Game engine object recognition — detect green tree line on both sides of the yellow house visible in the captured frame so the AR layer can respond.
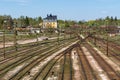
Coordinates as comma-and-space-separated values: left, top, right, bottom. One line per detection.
0, 15, 120, 29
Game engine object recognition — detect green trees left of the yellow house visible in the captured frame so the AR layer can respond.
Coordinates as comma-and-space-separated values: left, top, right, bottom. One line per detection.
0, 15, 43, 29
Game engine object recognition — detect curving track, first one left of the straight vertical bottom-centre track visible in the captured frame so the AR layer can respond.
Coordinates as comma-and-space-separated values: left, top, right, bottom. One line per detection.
32, 49, 64, 80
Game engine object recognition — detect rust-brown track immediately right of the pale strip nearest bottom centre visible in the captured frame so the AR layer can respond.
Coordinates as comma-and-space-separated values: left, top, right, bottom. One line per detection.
76, 45, 99, 80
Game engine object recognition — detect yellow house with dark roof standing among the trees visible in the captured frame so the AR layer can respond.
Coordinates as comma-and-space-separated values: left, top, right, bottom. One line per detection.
43, 14, 57, 28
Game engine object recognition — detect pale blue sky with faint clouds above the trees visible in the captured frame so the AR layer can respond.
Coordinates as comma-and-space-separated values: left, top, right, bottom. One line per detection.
0, 0, 120, 21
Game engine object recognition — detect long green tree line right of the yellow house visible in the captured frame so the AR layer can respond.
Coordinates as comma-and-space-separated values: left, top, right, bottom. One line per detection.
58, 16, 120, 27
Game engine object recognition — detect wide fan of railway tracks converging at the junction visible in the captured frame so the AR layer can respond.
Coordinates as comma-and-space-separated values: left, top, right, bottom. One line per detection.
0, 32, 120, 80
